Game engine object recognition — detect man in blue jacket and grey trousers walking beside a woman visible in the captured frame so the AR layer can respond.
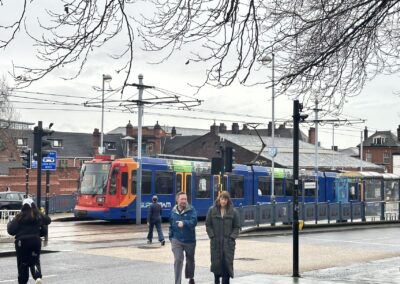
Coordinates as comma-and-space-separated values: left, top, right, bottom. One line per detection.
169, 191, 197, 284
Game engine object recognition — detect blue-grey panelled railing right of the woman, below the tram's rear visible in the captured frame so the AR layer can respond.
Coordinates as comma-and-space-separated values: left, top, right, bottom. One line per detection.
238, 201, 400, 227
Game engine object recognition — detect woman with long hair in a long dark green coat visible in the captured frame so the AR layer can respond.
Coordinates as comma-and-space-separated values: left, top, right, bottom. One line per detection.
206, 191, 240, 284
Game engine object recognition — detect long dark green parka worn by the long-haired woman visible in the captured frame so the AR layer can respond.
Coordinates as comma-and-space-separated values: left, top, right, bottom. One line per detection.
206, 205, 240, 278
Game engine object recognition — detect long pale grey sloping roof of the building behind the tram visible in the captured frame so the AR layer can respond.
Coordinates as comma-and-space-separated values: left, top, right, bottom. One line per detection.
219, 134, 382, 170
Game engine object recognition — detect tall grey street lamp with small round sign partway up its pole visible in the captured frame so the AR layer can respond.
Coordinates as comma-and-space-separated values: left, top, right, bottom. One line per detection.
261, 51, 277, 201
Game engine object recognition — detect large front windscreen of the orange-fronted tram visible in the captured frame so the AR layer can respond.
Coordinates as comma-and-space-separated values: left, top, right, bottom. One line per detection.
80, 163, 111, 194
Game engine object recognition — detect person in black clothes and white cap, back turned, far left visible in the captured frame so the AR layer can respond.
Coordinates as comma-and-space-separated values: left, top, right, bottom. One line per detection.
7, 198, 51, 284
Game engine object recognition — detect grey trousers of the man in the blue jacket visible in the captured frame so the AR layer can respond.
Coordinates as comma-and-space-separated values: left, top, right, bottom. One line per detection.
171, 239, 196, 284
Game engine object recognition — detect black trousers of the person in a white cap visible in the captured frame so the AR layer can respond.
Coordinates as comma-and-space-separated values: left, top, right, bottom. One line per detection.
15, 237, 42, 284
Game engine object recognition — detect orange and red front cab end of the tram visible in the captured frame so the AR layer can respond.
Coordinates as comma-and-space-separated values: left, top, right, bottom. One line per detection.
74, 155, 138, 220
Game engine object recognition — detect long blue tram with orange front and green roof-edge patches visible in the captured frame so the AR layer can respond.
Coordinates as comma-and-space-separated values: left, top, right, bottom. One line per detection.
74, 155, 399, 220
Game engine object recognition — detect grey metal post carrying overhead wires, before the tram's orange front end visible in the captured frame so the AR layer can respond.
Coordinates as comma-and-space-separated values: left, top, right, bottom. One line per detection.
136, 74, 144, 225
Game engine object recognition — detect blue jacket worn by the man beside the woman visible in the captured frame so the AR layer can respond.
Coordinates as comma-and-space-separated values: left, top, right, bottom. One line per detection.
169, 204, 197, 243
